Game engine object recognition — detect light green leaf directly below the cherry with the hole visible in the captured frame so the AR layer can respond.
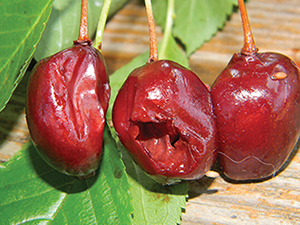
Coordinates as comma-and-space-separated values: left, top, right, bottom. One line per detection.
120, 141, 188, 225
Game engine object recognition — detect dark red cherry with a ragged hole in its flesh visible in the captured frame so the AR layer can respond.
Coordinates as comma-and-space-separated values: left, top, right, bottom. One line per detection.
113, 60, 217, 183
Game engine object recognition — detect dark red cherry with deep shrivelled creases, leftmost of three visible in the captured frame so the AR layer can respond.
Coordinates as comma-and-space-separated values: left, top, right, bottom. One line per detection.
26, 45, 110, 177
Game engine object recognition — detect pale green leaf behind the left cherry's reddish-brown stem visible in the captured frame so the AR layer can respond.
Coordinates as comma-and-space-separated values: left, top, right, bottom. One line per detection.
34, 0, 129, 61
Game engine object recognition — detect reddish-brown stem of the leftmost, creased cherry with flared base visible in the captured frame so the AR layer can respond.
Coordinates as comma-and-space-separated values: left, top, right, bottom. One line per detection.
74, 0, 92, 45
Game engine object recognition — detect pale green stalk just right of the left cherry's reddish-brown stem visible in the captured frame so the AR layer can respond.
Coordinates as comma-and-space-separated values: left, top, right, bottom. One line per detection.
94, 0, 111, 51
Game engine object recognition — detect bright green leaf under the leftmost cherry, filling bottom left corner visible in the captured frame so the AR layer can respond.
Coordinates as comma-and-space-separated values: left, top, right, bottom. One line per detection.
0, 129, 133, 225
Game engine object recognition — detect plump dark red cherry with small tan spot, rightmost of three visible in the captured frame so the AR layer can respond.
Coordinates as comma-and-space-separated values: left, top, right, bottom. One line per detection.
211, 53, 300, 180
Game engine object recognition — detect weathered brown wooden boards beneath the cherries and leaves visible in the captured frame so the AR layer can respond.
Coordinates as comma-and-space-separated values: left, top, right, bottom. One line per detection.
0, 0, 300, 225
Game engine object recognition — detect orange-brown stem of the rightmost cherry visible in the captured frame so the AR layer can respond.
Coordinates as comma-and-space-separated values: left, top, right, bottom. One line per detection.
238, 0, 258, 55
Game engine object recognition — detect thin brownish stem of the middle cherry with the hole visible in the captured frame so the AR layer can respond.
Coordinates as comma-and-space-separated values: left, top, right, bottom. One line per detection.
145, 0, 158, 62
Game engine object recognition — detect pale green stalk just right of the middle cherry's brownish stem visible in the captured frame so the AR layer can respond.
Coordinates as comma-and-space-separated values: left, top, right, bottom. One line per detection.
159, 0, 175, 59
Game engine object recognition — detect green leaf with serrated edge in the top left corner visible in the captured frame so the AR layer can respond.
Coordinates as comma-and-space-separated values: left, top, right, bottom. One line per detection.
0, 0, 53, 111
